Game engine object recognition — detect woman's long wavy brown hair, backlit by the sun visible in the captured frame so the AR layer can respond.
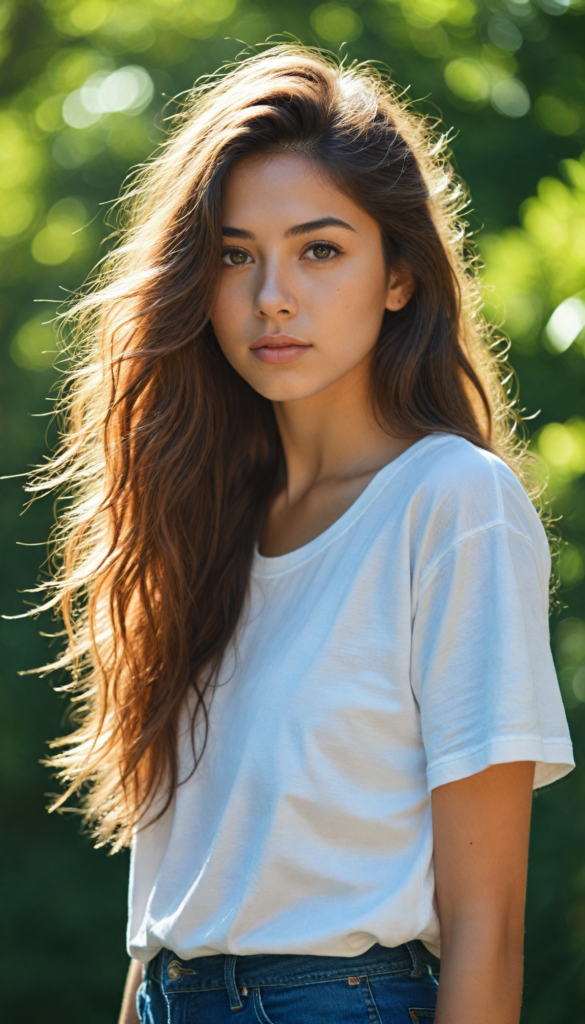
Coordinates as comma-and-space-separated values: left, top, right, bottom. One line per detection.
26, 44, 521, 846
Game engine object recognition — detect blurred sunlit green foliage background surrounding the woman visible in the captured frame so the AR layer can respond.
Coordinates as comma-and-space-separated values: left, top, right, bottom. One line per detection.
0, 0, 585, 1024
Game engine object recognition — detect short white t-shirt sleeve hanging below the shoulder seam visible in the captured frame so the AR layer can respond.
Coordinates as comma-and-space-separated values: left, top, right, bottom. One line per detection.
411, 520, 575, 791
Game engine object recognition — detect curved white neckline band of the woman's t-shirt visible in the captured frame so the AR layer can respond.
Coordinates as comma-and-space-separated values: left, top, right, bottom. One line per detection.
252, 433, 453, 577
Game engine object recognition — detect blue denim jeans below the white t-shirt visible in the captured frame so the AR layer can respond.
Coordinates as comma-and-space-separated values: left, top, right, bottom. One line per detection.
137, 941, 437, 1024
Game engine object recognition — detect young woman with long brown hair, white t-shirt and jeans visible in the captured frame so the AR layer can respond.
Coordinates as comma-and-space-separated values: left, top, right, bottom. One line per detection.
34, 46, 573, 1024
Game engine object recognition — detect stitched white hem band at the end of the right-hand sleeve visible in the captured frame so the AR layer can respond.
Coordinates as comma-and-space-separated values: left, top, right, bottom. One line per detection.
426, 736, 575, 792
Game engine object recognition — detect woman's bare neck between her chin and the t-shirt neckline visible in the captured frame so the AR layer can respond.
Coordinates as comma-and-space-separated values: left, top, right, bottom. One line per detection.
275, 357, 413, 503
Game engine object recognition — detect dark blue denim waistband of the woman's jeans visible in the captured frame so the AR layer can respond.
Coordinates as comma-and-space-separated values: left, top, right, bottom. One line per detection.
147, 940, 436, 994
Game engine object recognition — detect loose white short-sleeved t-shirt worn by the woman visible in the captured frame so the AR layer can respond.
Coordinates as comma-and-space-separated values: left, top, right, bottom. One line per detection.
128, 434, 574, 963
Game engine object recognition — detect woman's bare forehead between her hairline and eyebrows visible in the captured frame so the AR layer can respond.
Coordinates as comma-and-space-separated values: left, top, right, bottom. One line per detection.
223, 153, 377, 230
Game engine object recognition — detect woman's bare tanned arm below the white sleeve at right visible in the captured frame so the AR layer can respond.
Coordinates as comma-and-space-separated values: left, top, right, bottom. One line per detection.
432, 761, 534, 1024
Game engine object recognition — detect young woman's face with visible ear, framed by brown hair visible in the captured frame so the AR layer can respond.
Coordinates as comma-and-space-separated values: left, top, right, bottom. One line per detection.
211, 154, 414, 401
